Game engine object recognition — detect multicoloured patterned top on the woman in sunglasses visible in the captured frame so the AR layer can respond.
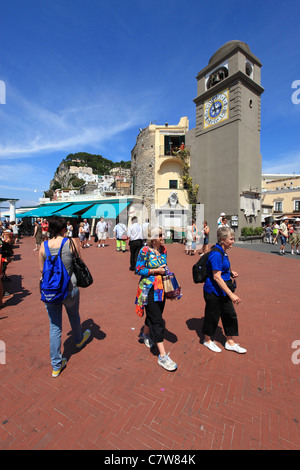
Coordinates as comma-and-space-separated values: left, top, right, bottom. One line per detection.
135, 245, 167, 317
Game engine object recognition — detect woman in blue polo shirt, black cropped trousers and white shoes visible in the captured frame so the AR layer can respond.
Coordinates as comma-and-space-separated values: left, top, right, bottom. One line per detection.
202, 227, 247, 354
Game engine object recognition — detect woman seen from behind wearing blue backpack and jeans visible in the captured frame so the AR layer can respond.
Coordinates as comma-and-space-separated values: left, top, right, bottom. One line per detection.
39, 216, 91, 377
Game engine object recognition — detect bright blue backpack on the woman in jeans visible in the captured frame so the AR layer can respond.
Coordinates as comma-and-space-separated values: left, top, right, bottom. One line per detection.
40, 238, 70, 303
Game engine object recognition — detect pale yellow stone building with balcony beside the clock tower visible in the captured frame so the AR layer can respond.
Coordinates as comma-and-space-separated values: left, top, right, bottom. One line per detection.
131, 117, 189, 230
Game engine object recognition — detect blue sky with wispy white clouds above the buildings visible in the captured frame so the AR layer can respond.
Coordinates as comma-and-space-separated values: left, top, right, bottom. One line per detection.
0, 0, 300, 206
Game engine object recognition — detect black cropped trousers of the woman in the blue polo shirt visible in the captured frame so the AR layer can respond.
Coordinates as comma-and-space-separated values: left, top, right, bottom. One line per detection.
202, 291, 239, 336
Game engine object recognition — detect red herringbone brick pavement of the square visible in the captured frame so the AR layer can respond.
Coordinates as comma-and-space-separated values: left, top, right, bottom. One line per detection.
0, 238, 300, 451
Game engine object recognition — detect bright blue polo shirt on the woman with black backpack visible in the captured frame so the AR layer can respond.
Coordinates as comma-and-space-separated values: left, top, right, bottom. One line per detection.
203, 243, 230, 296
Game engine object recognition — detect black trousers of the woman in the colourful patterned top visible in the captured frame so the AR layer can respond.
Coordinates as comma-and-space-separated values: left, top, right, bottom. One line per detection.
145, 287, 165, 343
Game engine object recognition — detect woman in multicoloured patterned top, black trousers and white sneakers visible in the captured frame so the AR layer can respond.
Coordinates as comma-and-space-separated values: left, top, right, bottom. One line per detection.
135, 230, 177, 371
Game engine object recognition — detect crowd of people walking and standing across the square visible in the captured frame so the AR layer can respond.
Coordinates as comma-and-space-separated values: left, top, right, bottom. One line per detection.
0, 213, 300, 377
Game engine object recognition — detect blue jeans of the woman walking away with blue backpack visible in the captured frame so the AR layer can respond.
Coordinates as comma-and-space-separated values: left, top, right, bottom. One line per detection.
45, 287, 83, 370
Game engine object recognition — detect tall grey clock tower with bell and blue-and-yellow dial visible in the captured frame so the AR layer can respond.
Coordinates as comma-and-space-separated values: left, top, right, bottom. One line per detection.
186, 41, 264, 242
